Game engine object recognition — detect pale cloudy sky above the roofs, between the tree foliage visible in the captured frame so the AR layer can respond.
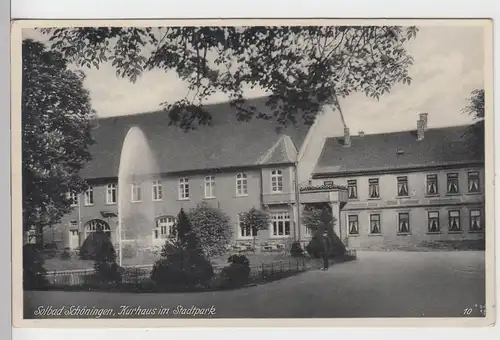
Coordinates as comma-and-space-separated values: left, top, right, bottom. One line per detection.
23, 25, 484, 135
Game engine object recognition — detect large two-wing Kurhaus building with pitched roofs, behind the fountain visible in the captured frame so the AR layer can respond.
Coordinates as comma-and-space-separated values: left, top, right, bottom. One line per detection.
39, 100, 484, 249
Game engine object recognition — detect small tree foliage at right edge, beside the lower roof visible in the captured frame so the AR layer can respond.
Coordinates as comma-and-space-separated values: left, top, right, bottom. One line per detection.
462, 89, 484, 157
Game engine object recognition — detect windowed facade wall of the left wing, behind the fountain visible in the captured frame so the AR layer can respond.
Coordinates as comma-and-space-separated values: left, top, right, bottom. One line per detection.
45, 165, 295, 248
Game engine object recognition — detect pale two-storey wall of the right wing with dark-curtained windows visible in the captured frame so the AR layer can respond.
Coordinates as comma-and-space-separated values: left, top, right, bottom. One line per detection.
314, 167, 484, 249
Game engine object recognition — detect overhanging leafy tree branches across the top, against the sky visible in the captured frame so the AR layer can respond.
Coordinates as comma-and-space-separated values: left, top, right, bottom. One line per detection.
40, 26, 418, 129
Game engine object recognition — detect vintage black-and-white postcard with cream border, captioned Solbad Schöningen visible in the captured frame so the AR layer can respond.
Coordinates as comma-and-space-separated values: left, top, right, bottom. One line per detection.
12, 19, 496, 327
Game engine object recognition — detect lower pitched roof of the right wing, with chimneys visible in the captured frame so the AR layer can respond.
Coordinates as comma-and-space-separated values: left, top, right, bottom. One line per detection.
313, 126, 484, 176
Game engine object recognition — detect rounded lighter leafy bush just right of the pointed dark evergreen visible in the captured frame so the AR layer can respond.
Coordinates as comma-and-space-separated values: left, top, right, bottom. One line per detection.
187, 203, 232, 257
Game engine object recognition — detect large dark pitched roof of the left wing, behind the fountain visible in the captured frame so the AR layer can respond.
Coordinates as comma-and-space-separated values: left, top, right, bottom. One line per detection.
82, 98, 309, 179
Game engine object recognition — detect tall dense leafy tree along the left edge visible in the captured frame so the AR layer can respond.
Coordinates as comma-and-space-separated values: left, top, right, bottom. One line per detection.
22, 40, 94, 247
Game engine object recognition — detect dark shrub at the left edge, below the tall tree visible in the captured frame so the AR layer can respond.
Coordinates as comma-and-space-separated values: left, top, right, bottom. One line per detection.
23, 244, 48, 290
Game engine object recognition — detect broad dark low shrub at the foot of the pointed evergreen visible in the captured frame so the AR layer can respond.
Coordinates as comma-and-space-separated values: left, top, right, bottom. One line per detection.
151, 244, 214, 287
